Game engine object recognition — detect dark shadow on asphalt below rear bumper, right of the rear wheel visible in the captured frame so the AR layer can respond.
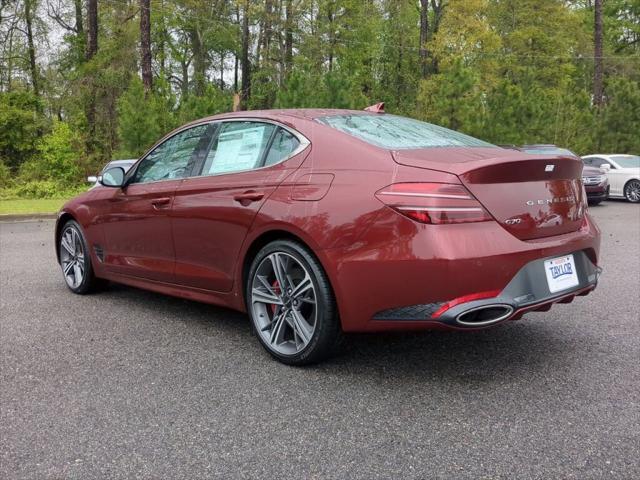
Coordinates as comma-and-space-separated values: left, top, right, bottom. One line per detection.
316, 317, 585, 388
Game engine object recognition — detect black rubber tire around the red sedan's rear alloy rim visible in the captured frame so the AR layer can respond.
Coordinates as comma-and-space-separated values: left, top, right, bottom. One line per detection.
245, 240, 342, 365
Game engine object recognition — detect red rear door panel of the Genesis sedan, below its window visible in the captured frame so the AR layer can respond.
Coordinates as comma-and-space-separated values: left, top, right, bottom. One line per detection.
171, 147, 308, 292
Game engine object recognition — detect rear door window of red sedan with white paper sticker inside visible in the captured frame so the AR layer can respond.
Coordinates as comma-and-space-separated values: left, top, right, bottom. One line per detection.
202, 121, 277, 175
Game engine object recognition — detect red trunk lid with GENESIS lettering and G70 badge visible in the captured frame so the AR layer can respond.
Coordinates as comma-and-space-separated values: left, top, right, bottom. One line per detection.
392, 148, 586, 240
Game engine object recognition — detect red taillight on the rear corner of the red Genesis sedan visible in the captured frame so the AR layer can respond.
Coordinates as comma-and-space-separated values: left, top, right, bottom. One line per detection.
376, 183, 493, 225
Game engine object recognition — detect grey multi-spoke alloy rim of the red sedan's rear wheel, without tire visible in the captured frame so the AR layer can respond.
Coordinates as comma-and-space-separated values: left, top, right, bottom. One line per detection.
251, 252, 318, 355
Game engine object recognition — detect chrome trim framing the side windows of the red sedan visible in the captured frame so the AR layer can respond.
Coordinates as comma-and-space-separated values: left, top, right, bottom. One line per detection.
125, 117, 311, 187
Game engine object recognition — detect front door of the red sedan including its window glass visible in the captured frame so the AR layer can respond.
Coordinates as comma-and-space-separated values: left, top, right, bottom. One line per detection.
100, 124, 211, 282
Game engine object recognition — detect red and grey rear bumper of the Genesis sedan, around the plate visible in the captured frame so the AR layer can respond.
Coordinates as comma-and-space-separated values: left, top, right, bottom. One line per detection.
323, 212, 600, 332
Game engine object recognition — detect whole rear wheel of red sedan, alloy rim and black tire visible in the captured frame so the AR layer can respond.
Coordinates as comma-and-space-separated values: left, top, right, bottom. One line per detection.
245, 240, 341, 365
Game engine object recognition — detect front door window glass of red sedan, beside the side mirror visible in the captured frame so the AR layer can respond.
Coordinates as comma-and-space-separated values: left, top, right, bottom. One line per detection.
132, 125, 210, 183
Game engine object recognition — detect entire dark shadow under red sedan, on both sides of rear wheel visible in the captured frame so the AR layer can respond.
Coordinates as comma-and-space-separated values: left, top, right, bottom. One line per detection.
105, 284, 585, 383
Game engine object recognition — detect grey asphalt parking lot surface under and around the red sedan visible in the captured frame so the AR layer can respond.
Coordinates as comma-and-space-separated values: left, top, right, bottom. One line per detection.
0, 201, 640, 479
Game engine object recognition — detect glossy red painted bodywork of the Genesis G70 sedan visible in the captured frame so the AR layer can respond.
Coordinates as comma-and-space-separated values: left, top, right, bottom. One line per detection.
55, 110, 600, 331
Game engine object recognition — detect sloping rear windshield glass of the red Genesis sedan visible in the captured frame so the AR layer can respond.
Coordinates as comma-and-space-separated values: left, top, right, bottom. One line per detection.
317, 114, 495, 150
